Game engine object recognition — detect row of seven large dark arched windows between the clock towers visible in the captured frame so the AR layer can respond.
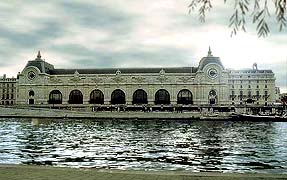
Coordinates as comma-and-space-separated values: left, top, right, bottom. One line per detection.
48, 89, 193, 104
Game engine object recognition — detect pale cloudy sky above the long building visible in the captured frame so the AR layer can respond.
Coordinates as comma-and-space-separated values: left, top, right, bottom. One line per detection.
0, 0, 287, 92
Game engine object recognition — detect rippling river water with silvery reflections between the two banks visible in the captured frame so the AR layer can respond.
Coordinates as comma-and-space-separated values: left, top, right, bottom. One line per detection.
0, 119, 287, 174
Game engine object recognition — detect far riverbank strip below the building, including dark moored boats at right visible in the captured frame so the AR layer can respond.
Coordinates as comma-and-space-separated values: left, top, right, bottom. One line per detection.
0, 106, 287, 122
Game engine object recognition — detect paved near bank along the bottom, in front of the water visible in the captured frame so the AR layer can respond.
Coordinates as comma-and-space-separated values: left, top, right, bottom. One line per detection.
0, 165, 287, 180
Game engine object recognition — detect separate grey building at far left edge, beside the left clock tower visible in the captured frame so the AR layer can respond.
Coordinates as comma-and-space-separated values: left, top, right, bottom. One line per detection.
0, 74, 16, 105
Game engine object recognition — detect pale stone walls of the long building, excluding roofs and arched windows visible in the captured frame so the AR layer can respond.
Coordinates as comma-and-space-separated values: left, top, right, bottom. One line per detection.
17, 53, 275, 105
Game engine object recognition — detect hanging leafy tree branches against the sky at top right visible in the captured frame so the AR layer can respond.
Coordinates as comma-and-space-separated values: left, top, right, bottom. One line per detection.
188, 0, 287, 37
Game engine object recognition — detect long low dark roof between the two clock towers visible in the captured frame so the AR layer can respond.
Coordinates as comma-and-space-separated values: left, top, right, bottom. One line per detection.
48, 67, 197, 75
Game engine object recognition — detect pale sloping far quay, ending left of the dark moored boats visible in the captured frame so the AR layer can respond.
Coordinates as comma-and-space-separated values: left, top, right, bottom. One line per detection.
0, 107, 231, 120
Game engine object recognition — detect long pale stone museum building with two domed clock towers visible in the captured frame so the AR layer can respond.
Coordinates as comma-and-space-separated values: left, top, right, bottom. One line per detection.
16, 49, 275, 107
